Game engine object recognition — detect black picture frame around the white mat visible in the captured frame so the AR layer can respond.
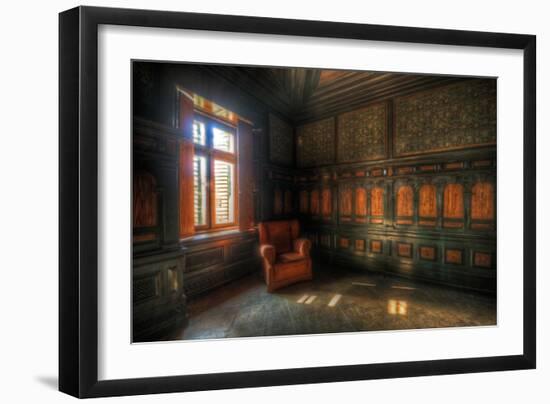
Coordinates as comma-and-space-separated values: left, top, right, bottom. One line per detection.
59, 7, 536, 398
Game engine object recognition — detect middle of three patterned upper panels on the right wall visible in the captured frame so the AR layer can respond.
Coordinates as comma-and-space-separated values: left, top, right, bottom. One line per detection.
338, 102, 387, 163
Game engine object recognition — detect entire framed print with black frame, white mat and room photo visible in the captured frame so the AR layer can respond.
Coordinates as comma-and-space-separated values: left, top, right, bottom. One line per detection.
59, 7, 536, 397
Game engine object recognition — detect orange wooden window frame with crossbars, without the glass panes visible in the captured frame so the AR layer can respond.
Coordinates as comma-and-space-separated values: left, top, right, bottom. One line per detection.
193, 113, 239, 233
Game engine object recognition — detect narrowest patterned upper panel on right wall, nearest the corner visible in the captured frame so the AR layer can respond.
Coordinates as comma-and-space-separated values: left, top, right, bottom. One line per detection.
296, 118, 335, 167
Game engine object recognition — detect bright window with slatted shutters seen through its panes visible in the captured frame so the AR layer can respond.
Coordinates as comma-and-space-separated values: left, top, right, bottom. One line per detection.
193, 117, 237, 230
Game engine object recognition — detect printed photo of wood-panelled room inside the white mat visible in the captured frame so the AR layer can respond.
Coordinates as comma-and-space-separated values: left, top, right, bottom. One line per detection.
132, 61, 497, 342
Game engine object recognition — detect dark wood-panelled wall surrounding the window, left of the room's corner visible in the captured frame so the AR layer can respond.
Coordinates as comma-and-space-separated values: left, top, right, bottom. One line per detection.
132, 62, 293, 341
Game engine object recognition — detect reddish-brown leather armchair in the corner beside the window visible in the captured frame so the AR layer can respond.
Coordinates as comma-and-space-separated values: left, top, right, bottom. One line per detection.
259, 220, 313, 292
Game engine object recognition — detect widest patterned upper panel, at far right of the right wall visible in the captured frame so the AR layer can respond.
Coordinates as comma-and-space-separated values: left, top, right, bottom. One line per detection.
394, 79, 496, 156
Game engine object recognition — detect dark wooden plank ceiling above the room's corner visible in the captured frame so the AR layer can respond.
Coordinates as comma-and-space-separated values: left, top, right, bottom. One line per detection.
208, 66, 457, 124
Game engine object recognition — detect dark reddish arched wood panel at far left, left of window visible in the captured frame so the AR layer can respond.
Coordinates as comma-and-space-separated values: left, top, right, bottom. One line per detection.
133, 171, 157, 227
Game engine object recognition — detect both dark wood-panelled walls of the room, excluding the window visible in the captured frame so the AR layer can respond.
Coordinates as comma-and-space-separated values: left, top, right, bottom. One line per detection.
132, 67, 496, 341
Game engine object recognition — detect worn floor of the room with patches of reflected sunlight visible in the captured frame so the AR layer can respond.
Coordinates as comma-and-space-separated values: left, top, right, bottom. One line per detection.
174, 271, 496, 339
